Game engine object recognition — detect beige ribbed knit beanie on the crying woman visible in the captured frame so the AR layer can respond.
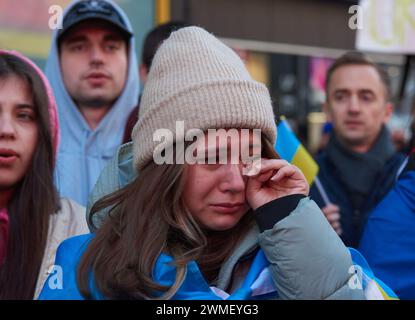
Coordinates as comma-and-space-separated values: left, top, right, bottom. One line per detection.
132, 27, 276, 170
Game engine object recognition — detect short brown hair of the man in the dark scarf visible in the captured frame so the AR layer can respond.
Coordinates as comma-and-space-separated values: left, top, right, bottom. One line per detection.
326, 51, 391, 101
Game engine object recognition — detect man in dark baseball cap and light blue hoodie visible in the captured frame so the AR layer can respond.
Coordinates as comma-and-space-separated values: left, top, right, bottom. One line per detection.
45, 0, 139, 205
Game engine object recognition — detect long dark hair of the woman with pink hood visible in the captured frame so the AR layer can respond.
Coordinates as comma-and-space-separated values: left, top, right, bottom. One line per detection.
0, 54, 59, 300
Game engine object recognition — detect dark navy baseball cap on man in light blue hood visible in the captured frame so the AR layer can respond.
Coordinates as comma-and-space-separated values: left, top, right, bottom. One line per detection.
58, 0, 133, 37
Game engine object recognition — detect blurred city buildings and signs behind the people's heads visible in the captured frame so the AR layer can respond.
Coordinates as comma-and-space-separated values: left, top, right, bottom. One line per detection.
0, 0, 415, 153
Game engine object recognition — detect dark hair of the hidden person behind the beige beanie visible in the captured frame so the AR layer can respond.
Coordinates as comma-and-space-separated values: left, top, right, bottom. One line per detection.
141, 21, 189, 70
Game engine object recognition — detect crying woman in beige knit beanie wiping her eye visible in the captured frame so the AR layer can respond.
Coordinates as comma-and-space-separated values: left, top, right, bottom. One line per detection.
40, 27, 394, 300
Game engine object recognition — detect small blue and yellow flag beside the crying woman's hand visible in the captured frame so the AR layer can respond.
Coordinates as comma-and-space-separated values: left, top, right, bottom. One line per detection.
275, 117, 318, 185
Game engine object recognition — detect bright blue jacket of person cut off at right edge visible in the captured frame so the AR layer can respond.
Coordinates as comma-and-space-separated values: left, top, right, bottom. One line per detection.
360, 155, 415, 299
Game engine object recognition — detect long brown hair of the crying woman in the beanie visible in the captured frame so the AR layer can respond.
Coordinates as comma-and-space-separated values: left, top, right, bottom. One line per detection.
77, 138, 278, 299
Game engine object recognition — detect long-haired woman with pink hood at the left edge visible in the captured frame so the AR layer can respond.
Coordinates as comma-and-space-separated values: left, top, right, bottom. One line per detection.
0, 50, 88, 300
